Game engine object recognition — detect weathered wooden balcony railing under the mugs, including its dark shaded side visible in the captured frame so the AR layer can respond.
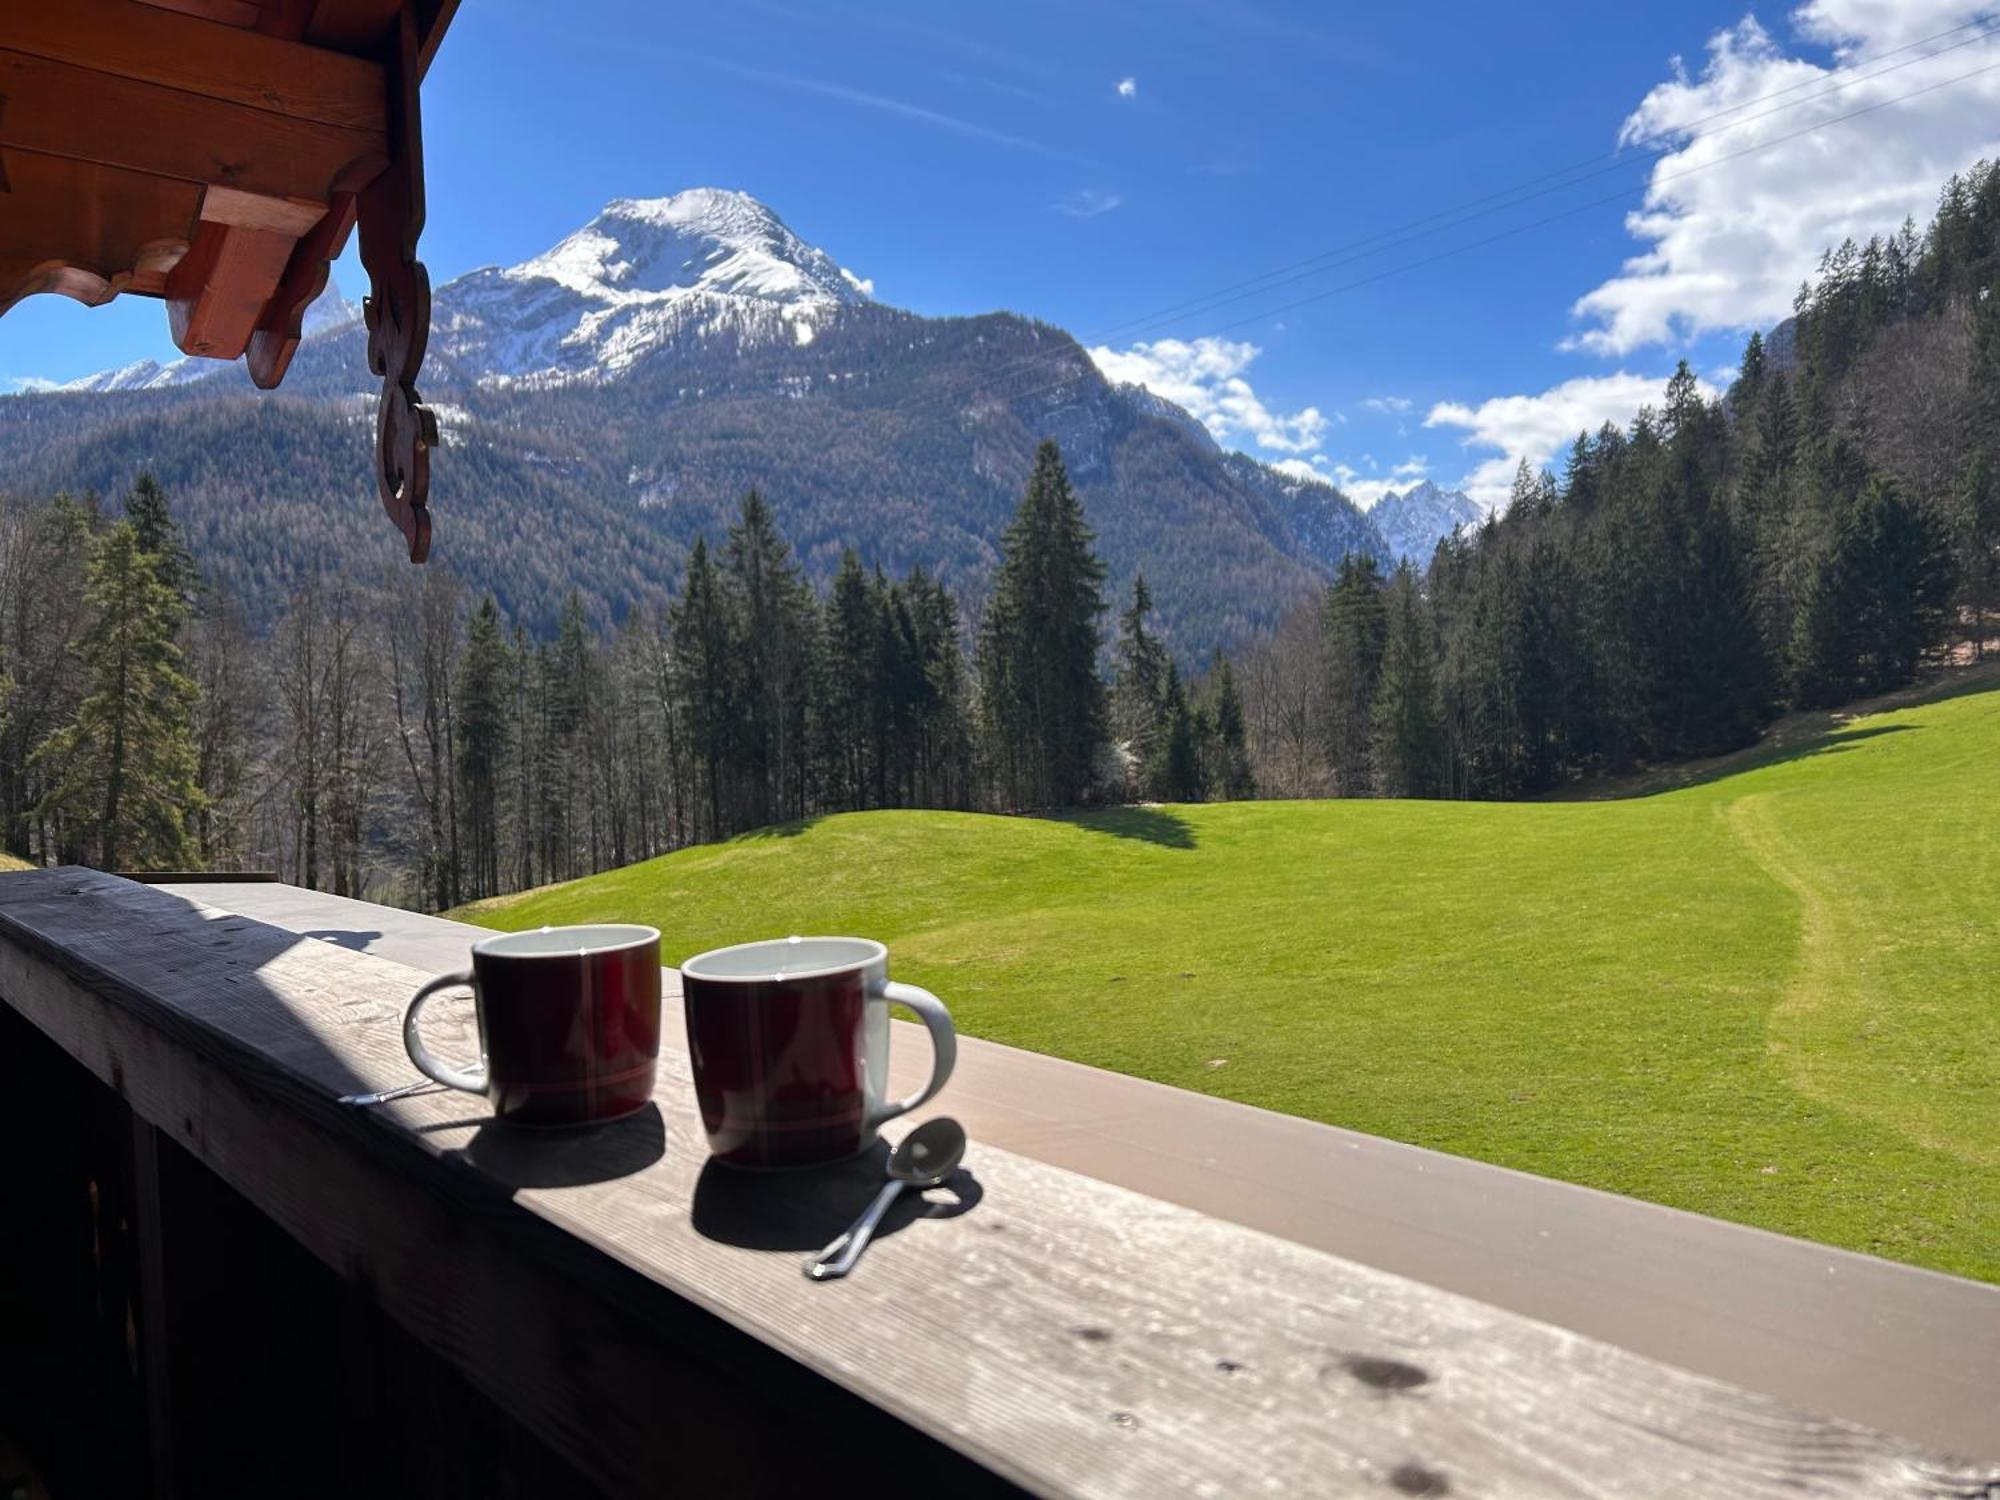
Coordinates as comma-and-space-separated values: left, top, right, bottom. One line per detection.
0, 870, 2000, 1500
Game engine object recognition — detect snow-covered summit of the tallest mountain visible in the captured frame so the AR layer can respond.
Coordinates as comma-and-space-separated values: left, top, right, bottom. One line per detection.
432, 188, 870, 384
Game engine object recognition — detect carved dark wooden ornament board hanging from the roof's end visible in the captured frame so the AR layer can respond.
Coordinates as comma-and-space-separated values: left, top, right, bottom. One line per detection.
356, 10, 438, 562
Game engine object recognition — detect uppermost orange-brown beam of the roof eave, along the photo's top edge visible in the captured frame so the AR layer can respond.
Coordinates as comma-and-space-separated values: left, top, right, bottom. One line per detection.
0, 0, 388, 132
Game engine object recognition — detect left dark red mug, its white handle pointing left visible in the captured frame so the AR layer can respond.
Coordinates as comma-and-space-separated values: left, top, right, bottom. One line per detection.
402, 924, 660, 1126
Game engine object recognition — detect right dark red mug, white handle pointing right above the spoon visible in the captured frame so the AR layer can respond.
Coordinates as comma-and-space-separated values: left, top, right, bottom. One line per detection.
680, 938, 958, 1168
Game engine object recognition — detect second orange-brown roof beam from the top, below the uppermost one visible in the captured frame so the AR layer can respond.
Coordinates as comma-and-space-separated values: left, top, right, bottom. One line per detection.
0, 48, 388, 210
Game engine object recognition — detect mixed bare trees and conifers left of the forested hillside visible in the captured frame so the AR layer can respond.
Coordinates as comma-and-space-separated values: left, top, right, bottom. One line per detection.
0, 434, 1248, 908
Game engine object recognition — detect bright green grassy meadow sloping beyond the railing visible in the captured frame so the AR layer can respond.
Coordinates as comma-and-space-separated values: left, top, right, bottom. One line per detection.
468, 688, 2000, 1280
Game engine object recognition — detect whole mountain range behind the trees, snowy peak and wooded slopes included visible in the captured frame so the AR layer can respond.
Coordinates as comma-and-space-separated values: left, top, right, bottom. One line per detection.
0, 188, 1464, 662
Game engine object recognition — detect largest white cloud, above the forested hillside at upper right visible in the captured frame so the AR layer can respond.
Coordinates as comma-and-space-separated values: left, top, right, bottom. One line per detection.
1570, 0, 2000, 354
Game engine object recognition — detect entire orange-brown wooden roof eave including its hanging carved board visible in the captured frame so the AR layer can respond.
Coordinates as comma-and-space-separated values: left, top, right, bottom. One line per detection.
0, 0, 456, 560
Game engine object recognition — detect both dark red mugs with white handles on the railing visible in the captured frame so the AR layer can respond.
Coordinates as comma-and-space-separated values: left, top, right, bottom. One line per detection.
402, 924, 958, 1168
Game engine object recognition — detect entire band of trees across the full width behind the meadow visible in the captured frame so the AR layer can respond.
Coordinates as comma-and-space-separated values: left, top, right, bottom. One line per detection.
0, 166, 2000, 908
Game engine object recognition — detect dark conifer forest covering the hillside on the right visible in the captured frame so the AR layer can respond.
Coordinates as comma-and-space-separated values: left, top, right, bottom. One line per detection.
1246, 164, 2000, 798
